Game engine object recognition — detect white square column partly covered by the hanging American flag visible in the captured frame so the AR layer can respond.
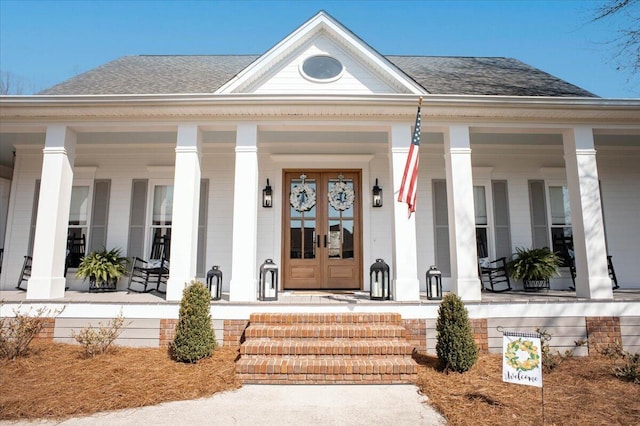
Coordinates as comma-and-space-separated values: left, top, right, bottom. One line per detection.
390, 124, 420, 301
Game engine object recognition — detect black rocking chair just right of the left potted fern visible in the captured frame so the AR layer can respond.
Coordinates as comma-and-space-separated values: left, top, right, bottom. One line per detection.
127, 235, 170, 293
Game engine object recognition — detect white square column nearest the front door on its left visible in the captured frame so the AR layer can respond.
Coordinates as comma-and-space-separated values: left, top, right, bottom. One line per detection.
229, 123, 258, 302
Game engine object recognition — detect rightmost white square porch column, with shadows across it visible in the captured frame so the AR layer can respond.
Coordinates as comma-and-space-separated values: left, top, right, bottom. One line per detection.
562, 126, 613, 299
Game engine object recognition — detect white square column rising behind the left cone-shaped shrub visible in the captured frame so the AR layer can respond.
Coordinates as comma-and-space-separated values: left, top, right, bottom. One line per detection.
166, 124, 202, 300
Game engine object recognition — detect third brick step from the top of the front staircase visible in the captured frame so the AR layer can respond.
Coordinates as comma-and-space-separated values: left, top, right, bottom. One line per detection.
240, 339, 413, 358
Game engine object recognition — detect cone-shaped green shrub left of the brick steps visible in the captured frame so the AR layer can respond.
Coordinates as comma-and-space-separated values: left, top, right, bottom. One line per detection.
171, 281, 216, 363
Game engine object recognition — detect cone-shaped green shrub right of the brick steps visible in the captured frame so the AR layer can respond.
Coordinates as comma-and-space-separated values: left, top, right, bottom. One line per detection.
436, 293, 478, 373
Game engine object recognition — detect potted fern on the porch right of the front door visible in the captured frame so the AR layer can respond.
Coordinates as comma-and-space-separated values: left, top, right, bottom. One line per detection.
507, 247, 562, 291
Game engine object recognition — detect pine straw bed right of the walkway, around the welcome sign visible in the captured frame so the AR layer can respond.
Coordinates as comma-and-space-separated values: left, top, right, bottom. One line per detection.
416, 355, 640, 425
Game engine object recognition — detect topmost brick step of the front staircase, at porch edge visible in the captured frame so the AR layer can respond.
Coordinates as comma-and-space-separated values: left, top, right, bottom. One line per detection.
249, 313, 402, 324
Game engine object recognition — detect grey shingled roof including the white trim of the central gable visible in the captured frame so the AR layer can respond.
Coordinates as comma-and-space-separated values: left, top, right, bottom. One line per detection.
39, 12, 595, 97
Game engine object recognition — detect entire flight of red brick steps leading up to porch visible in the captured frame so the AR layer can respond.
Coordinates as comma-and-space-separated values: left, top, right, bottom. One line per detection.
236, 313, 417, 384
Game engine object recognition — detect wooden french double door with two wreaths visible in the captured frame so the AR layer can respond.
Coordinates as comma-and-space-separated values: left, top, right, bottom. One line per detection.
282, 169, 362, 290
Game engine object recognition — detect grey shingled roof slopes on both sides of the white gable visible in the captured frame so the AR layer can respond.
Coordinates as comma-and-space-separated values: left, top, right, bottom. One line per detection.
39, 55, 595, 97
